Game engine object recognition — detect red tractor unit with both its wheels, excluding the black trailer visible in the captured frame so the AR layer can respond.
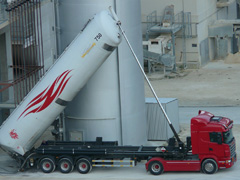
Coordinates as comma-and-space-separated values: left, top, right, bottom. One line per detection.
145, 111, 237, 175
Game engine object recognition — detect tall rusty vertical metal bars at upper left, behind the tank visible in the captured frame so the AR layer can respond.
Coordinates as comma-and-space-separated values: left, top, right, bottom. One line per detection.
0, 0, 44, 105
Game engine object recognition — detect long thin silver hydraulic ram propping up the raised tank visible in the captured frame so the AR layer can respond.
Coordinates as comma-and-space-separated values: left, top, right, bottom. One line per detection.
109, 6, 181, 142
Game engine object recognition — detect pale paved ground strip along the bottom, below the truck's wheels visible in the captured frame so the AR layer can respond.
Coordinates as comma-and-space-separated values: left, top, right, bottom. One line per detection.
0, 164, 240, 180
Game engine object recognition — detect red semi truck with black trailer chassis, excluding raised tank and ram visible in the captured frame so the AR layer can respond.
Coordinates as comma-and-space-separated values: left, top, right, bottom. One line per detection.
27, 111, 237, 175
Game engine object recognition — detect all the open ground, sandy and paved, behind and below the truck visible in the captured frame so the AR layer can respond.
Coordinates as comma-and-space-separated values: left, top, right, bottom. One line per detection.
0, 61, 240, 180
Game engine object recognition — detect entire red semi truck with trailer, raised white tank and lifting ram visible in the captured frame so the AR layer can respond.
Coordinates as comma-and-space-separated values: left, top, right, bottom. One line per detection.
0, 8, 237, 175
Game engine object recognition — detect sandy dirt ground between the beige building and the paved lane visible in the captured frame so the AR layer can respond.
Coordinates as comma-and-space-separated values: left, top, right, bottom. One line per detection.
145, 59, 240, 106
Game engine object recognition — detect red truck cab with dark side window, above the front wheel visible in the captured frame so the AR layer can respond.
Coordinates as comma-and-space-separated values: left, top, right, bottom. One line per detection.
191, 111, 237, 172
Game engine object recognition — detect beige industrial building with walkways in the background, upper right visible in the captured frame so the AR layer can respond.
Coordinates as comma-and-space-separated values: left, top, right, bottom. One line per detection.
141, 0, 239, 68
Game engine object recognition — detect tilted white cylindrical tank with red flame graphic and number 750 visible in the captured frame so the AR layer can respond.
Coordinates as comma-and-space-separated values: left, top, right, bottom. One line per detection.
0, 11, 121, 155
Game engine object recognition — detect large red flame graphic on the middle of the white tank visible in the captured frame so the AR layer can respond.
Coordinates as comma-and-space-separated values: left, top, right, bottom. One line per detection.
18, 70, 72, 119
